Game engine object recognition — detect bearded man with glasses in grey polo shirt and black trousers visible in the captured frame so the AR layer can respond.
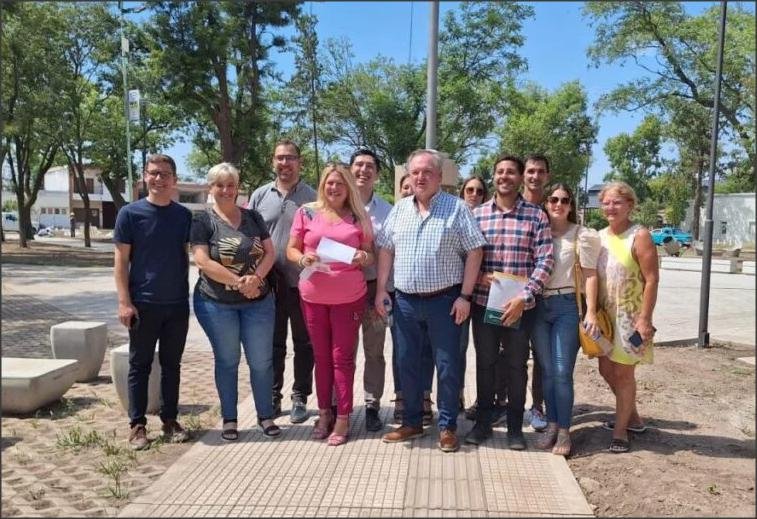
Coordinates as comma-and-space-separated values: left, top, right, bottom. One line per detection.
248, 139, 316, 423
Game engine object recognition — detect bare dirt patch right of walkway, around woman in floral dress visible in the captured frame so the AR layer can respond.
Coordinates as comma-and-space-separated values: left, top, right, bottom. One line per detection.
568, 346, 755, 517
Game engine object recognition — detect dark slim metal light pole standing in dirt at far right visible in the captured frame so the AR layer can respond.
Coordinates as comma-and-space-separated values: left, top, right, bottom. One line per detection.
698, 1, 727, 348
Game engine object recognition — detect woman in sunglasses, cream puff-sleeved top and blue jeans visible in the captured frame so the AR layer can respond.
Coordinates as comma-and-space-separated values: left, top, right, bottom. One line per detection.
531, 184, 600, 456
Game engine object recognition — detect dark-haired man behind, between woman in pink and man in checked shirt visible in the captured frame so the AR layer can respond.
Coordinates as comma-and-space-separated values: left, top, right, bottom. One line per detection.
350, 148, 394, 431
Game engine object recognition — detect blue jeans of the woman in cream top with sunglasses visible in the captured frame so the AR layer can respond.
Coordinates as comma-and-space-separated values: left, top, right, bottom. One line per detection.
531, 294, 578, 429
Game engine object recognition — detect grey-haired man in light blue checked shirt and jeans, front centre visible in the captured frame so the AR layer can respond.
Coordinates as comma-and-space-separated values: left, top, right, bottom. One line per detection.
375, 150, 486, 452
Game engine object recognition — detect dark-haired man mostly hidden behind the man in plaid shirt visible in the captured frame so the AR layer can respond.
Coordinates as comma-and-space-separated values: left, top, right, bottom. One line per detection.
512, 154, 550, 431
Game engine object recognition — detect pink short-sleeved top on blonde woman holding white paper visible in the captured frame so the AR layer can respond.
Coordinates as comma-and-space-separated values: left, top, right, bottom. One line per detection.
291, 207, 367, 305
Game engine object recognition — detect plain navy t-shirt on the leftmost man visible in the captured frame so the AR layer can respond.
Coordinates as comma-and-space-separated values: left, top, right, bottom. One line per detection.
113, 198, 192, 305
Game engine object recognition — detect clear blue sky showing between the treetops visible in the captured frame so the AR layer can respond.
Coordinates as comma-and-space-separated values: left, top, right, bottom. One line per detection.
158, 1, 732, 185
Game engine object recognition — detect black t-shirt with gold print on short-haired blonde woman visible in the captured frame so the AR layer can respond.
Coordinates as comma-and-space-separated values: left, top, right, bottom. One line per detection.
189, 208, 270, 304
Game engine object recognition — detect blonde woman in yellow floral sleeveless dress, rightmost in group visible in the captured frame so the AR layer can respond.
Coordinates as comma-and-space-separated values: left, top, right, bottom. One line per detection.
597, 182, 659, 453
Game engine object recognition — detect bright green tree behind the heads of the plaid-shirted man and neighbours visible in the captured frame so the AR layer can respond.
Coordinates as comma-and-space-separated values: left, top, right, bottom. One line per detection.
497, 81, 597, 191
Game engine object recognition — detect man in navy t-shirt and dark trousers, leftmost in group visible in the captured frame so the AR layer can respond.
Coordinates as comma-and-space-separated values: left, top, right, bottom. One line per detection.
113, 154, 192, 450
